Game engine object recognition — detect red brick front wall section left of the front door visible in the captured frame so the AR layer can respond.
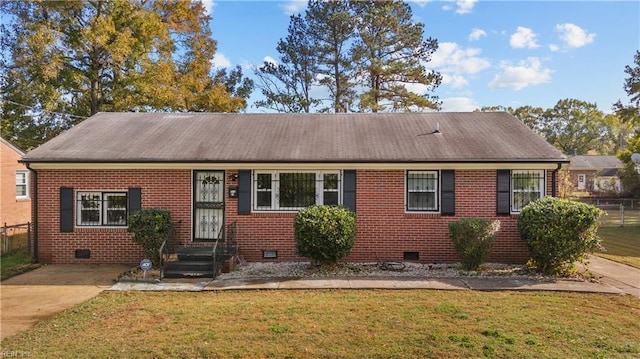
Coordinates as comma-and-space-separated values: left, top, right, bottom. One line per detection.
37, 170, 191, 264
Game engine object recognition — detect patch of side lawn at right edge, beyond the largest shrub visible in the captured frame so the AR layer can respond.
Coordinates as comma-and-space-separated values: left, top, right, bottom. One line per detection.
595, 225, 640, 268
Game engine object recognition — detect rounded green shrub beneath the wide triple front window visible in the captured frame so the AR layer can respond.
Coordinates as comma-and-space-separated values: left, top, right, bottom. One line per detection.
294, 206, 356, 265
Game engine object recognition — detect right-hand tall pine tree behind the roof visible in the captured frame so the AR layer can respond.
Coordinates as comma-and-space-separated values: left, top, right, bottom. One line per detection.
351, 0, 442, 112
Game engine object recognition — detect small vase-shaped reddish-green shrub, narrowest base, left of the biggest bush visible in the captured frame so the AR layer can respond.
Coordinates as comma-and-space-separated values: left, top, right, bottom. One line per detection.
449, 218, 500, 270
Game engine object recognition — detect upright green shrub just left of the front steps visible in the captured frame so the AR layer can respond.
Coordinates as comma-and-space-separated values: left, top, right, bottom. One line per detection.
127, 208, 173, 266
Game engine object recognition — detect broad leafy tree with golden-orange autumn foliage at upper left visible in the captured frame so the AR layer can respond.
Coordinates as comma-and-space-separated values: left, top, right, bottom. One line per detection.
0, 0, 253, 150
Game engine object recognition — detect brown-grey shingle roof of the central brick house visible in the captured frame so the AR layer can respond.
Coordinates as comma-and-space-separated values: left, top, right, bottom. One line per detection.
23, 112, 566, 163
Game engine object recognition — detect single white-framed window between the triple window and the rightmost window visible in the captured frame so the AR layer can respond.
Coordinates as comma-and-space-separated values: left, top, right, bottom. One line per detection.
406, 171, 440, 212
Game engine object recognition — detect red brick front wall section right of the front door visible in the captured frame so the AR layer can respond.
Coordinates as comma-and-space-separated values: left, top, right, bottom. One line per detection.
226, 170, 551, 263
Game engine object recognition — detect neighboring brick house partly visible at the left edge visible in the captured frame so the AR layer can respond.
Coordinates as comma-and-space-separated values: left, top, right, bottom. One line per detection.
0, 137, 31, 226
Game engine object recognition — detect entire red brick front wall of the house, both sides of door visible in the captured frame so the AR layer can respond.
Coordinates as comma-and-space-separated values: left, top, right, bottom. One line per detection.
38, 170, 551, 264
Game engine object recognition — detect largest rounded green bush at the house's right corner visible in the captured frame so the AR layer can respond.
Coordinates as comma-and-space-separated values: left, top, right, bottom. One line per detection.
518, 197, 602, 274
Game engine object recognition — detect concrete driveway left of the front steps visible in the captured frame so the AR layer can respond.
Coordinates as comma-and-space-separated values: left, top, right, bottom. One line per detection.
0, 264, 133, 339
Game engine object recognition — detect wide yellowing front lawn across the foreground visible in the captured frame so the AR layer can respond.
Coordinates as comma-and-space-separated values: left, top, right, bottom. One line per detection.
1, 290, 640, 358
